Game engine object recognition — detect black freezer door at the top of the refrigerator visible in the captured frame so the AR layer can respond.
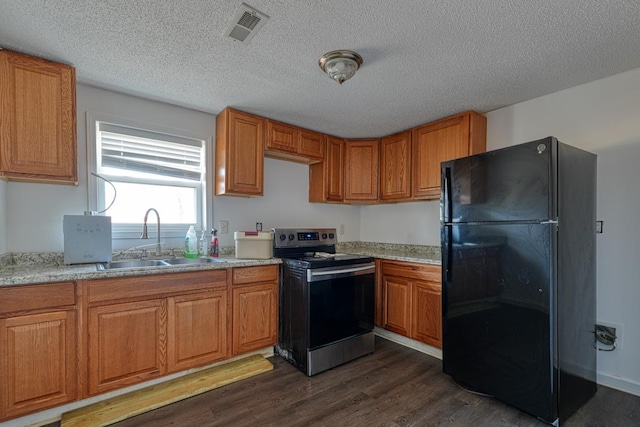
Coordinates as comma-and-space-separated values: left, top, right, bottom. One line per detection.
441, 137, 557, 223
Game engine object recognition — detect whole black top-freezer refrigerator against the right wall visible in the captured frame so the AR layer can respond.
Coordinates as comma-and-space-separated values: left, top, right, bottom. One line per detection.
440, 137, 597, 425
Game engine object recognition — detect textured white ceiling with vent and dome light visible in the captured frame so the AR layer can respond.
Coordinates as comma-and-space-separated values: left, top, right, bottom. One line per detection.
0, 0, 640, 137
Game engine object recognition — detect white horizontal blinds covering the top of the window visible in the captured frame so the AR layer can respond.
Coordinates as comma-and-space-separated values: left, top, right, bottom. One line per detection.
98, 122, 203, 181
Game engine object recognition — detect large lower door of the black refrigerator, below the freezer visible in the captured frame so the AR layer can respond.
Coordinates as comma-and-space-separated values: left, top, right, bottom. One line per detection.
442, 224, 557, 422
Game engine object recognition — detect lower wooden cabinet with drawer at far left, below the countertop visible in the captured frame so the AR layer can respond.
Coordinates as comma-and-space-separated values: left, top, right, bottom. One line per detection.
0, 282, 79, 424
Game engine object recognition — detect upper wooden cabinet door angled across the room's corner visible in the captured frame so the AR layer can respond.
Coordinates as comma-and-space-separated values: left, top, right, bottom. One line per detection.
344, 139, 380, 202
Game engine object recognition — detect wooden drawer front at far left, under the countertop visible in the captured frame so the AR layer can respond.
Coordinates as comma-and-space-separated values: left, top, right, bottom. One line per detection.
0, 282, 76, 314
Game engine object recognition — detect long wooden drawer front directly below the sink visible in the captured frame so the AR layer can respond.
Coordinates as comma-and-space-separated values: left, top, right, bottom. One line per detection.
87, 269, 227, 303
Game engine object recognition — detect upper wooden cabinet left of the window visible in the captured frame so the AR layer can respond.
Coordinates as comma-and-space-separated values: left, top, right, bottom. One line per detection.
0, 50, 78, 184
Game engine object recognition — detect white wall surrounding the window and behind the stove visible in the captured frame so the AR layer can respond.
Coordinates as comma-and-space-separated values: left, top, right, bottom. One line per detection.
0, 84, 360, 254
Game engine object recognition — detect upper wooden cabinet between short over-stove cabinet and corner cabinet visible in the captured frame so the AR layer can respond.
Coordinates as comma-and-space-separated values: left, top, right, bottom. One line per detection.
309, 136, 344, 203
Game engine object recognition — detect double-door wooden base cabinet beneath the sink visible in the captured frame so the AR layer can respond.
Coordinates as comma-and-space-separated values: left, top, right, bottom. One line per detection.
83, 269, 230, 396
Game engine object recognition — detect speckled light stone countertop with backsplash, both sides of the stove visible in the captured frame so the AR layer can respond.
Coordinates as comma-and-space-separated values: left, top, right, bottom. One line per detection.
0, 242, 440, 286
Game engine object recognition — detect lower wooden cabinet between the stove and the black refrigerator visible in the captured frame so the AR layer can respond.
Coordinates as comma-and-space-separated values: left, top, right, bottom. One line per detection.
376, 260, 442, 348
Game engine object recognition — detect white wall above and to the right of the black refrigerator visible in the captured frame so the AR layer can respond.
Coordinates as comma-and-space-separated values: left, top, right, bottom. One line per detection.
487, 69, 640, 395
